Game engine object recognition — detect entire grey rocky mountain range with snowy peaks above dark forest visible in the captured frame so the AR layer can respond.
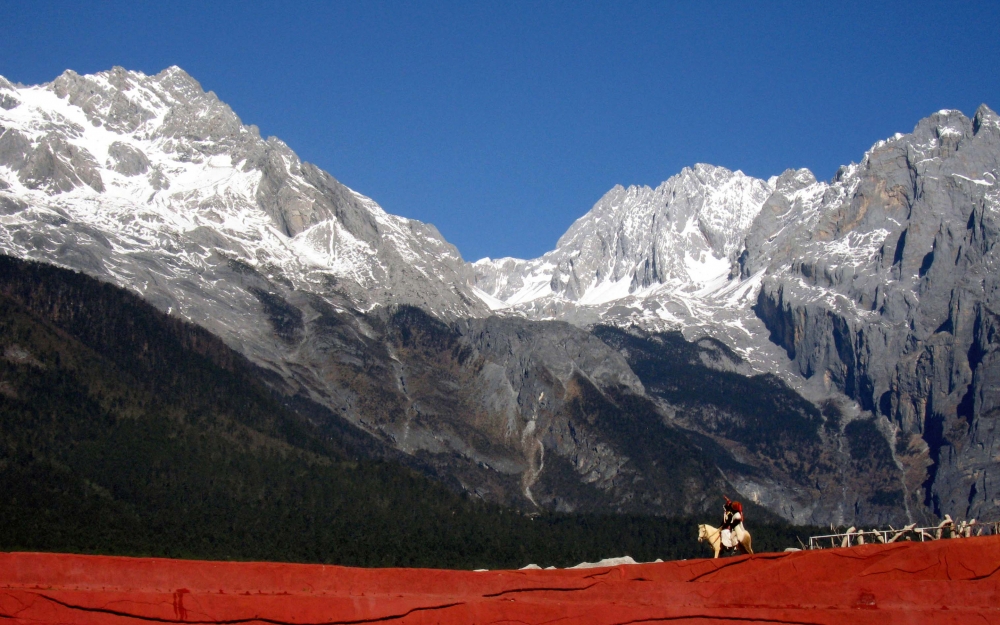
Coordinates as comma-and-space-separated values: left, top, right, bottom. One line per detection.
0, 68, 1000, 524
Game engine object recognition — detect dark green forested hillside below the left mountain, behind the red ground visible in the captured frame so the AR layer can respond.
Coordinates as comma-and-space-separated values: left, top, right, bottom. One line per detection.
0, 257, 808, 568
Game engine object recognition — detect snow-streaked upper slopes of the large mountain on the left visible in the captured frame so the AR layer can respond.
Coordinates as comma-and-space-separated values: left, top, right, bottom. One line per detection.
0, 67, 486, 342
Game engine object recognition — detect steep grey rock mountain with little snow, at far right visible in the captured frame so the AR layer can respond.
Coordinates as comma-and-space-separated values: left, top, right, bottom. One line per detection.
741, 106, 1000, 517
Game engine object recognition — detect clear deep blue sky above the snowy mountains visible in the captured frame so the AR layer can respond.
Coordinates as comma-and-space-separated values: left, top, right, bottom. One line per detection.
0, 0, 1000, 260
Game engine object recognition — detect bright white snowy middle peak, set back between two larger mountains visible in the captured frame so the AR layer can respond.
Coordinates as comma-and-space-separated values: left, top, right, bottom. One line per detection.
474, 163, 773, 316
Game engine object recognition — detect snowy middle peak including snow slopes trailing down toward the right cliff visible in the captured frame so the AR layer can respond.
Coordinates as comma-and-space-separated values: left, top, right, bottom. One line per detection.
473, 164, 792, 369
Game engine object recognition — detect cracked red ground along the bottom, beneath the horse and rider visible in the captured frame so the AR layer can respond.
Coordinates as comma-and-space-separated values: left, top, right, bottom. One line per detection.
0, 537, 1000, 625
